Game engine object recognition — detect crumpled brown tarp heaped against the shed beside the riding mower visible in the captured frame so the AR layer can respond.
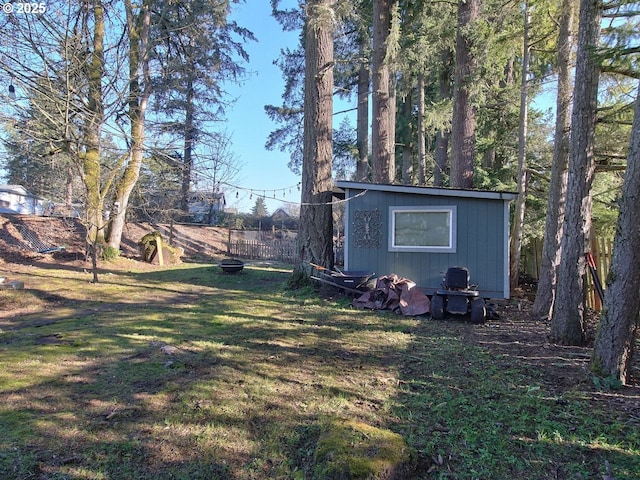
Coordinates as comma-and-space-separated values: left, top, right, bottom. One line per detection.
352, 273, 431, 316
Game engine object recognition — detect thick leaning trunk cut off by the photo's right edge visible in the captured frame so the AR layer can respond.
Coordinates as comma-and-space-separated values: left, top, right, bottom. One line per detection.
591, 81, 640, 385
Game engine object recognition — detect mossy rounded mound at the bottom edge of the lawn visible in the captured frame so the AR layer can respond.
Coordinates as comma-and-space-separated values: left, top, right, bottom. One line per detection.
313, 420, 415, 480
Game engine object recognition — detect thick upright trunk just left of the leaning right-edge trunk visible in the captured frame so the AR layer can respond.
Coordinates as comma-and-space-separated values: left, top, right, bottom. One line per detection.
551, 0, 602, 345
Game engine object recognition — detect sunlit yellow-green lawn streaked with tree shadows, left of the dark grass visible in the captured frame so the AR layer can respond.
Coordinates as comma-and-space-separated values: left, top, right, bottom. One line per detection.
0, 268, 415, 479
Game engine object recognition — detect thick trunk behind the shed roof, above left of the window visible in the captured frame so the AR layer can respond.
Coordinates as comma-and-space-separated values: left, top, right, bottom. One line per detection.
371, 0, 395, 183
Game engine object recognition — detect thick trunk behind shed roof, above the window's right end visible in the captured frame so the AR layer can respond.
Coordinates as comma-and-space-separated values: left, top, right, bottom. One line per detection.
450, 0, 480, 188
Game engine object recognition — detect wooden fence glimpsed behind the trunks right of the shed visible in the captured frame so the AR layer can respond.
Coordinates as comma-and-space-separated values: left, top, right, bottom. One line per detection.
521, 238, 613, 311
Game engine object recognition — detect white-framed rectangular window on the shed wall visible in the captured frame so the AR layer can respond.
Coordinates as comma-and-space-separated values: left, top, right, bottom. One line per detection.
389, 205, 457, 253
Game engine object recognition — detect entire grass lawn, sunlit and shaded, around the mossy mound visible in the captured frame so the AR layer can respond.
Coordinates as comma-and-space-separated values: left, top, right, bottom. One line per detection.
0, 264, 640, 480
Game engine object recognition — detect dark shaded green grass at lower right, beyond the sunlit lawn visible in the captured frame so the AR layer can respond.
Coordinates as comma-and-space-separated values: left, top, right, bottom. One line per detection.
396, 312, 640, 480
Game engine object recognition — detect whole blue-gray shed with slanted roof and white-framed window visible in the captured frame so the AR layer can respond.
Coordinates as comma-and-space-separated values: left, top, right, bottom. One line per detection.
336, 181, 517, 298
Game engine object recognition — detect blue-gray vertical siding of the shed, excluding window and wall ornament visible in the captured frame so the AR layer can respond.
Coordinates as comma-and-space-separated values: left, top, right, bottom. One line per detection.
342, 186, 509, 298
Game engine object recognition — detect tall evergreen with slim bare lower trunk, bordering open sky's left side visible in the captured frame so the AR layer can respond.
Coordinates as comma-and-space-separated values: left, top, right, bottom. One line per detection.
152, 0, 255, 212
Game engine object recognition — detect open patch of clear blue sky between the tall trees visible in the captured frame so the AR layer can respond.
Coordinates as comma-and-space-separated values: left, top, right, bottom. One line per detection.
225, 0, 300, 214
